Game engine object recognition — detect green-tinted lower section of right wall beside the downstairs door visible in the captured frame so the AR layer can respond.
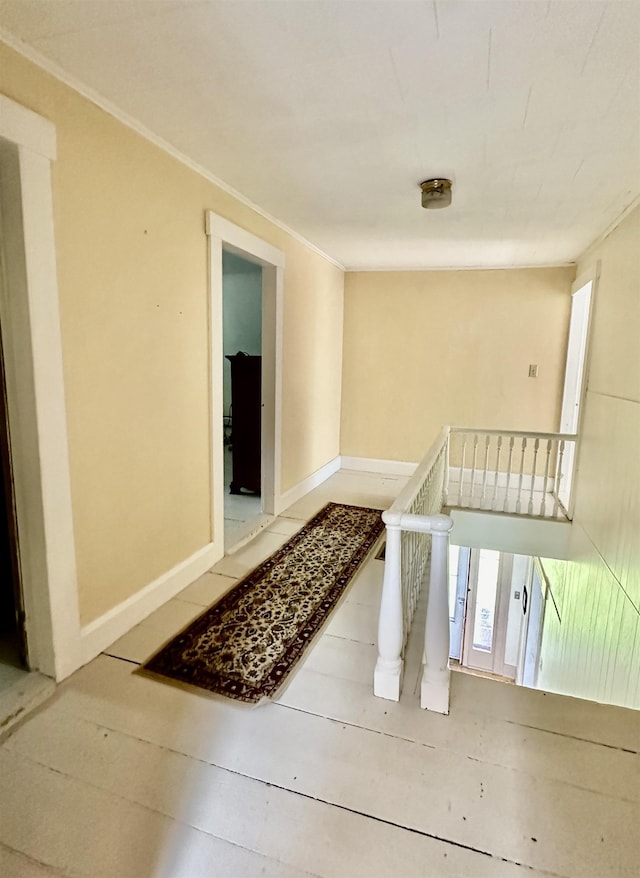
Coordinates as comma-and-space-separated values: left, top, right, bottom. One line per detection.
538, 524, 640, 709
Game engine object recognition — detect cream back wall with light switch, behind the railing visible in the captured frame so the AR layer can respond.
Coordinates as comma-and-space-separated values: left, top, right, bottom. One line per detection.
341, 267, 574, 461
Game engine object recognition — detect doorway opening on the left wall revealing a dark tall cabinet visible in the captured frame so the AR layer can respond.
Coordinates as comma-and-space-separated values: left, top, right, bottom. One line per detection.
222, 248, 262, 547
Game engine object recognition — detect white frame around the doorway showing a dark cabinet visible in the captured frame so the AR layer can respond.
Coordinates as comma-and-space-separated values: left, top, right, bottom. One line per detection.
205, 210, 285, 556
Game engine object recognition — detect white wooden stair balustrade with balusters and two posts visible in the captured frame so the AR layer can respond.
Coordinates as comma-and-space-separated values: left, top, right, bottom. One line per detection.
374, 427, 578, 714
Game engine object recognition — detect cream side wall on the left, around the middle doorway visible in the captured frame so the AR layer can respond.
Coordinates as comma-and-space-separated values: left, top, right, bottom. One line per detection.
0, 44, 343, 624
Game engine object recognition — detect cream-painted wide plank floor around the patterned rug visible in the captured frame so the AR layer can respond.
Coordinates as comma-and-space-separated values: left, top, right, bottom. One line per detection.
0, 472, 640, 878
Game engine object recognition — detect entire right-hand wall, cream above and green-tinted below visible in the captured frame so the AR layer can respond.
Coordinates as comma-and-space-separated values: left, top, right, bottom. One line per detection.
539, 207, 640, 708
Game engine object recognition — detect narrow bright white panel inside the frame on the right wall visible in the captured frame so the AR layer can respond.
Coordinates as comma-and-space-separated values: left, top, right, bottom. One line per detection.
558, 281, 593, 511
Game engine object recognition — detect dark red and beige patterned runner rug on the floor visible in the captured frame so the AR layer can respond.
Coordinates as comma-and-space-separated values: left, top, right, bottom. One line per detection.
145, 503, 384, 704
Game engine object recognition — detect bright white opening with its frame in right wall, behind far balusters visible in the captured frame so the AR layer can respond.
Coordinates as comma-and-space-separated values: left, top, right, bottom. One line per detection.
558, 262, 600, 519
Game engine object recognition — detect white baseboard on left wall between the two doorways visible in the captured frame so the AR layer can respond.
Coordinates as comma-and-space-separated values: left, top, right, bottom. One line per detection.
80, 543, 220, 664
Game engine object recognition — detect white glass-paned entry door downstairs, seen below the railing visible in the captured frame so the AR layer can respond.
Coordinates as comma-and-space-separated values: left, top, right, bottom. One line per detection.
449, 545, 545, 687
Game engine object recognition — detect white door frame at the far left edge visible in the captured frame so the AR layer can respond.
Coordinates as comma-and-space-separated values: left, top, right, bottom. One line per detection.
0, 95, 82, 680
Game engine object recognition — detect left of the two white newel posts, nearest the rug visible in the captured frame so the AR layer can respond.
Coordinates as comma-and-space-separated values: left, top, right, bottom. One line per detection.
373, 511, 404, 701
